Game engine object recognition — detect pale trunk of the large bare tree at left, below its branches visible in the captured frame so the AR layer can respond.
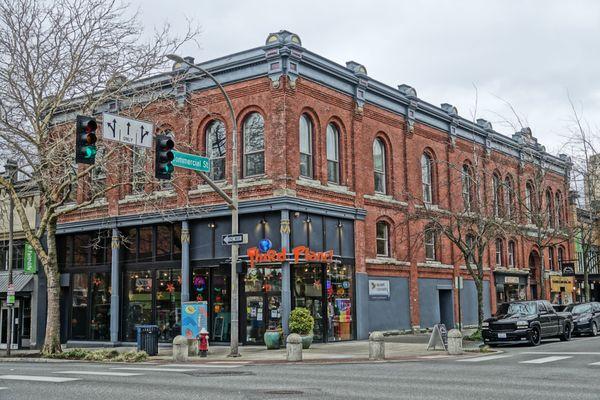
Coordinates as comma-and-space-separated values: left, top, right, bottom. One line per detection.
42, 220, 62, 354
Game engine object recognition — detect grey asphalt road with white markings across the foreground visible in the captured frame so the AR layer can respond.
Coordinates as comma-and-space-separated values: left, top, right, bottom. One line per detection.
0, 337, 600, 400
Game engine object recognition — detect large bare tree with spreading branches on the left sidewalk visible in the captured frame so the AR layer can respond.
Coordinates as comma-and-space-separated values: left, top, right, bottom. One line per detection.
0, 0, 198, 353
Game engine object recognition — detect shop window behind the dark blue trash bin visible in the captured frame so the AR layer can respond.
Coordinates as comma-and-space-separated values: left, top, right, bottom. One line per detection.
123, 271, 152, 342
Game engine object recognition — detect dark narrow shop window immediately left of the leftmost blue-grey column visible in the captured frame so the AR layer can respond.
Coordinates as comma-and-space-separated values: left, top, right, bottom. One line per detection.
90, 273, 110, 340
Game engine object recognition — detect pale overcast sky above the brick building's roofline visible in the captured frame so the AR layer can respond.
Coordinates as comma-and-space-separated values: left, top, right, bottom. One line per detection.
137, 0, 600, 153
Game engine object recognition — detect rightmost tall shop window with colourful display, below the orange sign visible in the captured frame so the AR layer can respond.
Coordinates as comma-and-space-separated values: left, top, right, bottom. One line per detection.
326, 264, 354, 341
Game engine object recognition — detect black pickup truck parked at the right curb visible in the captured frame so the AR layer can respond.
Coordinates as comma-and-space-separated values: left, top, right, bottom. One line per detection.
482, 300, 573, 346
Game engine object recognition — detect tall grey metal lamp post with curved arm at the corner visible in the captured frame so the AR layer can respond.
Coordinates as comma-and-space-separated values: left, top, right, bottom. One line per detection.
166, 54, 240, 357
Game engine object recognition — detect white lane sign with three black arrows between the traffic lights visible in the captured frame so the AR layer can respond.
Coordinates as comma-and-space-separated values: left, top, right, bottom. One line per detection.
102, 113, 154, 148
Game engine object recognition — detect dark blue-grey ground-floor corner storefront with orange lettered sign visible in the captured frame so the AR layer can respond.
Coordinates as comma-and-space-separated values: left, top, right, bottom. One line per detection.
59, 205, 357, 344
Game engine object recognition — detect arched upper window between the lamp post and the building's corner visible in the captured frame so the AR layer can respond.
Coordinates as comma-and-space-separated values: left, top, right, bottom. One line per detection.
243, 112, 265, 177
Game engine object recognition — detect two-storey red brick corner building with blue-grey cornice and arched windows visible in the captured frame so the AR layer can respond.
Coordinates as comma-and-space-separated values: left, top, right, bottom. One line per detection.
52, 31, 572, 344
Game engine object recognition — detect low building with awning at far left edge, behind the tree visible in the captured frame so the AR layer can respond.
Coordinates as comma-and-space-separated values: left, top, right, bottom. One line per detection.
0, 177, 46, 349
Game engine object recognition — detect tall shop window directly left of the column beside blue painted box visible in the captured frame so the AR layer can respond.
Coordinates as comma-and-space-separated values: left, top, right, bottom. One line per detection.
156, 269, 181, 342
